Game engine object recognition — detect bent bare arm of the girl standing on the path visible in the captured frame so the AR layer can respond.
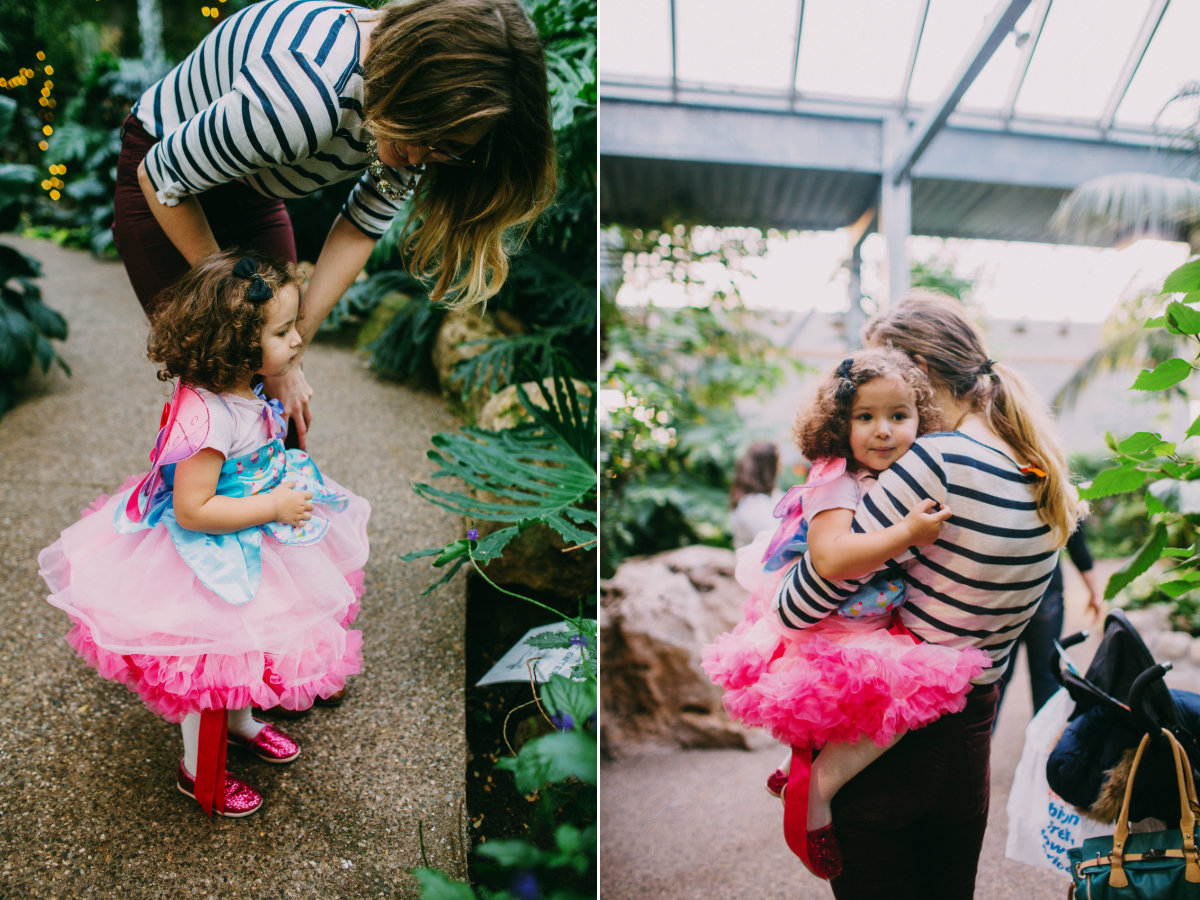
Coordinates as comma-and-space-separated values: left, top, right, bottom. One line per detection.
174, 448, 312, 534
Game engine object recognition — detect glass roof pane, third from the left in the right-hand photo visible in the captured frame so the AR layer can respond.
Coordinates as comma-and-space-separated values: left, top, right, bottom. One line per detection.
792, 0, 919, 101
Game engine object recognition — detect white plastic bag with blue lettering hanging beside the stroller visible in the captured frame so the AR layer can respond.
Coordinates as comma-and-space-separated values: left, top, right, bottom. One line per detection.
1004, 690, 1115, 871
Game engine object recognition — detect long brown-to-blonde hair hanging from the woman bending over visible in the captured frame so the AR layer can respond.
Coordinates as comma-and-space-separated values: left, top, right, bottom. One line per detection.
362, 0, 557, 307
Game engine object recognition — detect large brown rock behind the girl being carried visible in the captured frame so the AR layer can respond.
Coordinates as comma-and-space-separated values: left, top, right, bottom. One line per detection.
600, 546, 769, 756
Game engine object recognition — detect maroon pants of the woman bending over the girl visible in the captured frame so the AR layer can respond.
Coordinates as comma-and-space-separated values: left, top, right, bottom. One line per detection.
113, 115, 296, 314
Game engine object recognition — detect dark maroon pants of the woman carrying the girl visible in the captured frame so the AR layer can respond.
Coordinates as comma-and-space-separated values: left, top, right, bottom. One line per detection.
832, 684, 1000, 900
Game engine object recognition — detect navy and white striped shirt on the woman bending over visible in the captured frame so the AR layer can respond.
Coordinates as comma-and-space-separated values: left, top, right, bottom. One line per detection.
133, 0, 415, 238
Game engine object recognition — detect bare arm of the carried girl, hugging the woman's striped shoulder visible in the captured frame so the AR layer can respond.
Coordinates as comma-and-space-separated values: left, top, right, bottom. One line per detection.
809, 500, 950, 581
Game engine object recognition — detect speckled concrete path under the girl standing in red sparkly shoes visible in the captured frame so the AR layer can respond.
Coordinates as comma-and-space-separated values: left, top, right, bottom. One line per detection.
0, 235, 468, 900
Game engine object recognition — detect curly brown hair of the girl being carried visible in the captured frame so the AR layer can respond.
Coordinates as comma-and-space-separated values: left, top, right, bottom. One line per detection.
792, 349, 942, 470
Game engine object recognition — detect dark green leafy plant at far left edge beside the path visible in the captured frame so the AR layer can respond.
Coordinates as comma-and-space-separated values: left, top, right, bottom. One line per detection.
0, 97, 71, 416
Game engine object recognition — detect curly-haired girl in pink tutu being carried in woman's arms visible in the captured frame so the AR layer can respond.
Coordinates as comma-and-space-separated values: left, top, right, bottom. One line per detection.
703, 350, 991, 878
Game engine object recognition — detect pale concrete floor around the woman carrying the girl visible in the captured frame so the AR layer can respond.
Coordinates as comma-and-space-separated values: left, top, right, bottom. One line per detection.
600, 560, 1116, 900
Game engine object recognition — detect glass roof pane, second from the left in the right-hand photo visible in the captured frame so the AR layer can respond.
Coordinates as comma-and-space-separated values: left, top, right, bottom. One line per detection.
676, 0, 798, 91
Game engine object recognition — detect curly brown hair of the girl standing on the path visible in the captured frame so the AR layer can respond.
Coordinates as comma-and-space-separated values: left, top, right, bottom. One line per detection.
146, 248, 300, 394
